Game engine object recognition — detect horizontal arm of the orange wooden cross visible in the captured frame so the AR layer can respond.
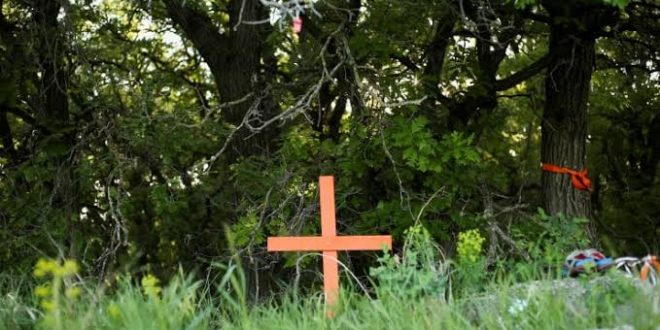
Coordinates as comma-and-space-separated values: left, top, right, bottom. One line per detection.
268, 235, 392, 252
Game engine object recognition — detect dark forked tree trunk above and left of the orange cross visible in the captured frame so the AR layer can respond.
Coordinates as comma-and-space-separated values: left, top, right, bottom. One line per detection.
164, 0, 279, 160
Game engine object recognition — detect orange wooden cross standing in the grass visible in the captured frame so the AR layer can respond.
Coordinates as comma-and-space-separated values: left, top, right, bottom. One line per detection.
268, 176, 392, 305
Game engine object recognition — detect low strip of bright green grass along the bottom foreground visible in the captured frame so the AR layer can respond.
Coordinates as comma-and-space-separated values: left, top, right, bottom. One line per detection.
0, 260, 660, 330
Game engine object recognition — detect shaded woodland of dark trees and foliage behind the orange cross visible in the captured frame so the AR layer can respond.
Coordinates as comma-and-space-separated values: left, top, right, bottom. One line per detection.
0, 0, 660, 297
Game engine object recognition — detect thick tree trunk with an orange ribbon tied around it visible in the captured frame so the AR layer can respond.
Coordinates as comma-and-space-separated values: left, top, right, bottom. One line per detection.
541, 0, 620, 241
